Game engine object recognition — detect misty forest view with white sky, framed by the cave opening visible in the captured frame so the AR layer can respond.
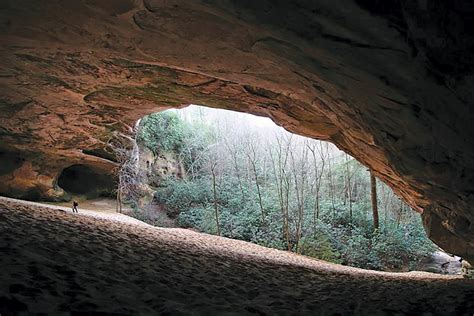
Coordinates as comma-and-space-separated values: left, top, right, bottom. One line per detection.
119, 106, 437, 271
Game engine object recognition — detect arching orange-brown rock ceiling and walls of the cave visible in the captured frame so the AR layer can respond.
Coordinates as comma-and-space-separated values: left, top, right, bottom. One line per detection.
0, 0, 474, 260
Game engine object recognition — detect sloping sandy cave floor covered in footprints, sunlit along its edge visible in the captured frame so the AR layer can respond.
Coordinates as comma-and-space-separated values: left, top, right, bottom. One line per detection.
0, 198, 474, 315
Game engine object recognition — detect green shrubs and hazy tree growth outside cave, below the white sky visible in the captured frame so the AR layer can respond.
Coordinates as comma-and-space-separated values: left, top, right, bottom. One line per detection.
132, 107, 435, 271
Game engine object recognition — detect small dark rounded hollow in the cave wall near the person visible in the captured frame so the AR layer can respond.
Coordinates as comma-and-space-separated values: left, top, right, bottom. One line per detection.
58, 164, 116, 199
